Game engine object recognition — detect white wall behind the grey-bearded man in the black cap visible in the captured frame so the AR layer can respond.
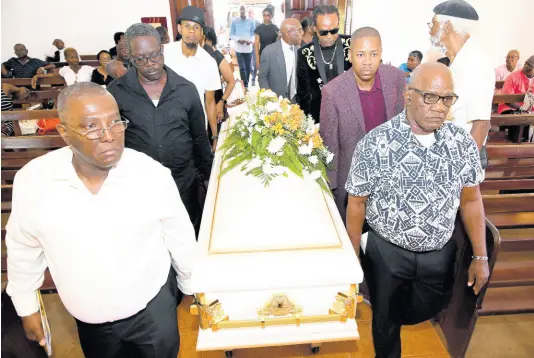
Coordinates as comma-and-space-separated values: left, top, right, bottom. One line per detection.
352, 0, 534, 67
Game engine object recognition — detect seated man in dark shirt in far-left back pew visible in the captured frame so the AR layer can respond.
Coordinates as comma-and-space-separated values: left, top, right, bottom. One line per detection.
2, 44, 56, 78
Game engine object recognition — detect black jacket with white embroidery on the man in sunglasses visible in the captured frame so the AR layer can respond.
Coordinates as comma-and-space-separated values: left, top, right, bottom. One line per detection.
297, 35, 352, 123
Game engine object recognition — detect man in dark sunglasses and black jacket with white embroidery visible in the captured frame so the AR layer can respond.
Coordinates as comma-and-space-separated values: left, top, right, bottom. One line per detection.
297, 5, 352, 122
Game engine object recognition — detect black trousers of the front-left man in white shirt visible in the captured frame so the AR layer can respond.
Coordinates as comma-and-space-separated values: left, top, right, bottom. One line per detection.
76, 268, 181, 358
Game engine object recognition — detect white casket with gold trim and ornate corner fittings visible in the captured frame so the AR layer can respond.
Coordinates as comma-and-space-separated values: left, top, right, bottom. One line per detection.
191, 104, 363, 351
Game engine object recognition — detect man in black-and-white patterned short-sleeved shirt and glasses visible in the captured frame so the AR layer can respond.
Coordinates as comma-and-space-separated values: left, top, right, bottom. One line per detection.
346, 63, 489, 358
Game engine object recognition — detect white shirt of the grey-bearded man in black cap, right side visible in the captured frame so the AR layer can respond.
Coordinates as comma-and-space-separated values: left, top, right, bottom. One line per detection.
448, 38, 495, 133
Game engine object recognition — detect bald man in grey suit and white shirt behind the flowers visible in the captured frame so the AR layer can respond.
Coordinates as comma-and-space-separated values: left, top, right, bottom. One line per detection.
259, 19, 302, 103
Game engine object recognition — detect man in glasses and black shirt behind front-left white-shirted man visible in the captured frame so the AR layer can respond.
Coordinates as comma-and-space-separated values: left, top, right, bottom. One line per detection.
107, 24, 213, 235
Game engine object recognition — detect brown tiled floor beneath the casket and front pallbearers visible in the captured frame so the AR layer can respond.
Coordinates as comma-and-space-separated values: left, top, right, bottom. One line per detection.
36, 295, 534, 358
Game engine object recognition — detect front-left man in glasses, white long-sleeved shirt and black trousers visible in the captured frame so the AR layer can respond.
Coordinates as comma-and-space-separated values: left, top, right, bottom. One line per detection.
6, 82, 196, 358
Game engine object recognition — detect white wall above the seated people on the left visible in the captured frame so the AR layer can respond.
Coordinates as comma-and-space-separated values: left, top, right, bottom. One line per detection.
1, 0, 175, 62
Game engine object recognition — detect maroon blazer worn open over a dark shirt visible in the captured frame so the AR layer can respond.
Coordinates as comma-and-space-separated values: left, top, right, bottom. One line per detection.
320, 65, 406, 220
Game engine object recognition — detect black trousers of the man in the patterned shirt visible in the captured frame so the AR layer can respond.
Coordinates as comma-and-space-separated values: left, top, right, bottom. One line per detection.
361, 230, 456, 358
